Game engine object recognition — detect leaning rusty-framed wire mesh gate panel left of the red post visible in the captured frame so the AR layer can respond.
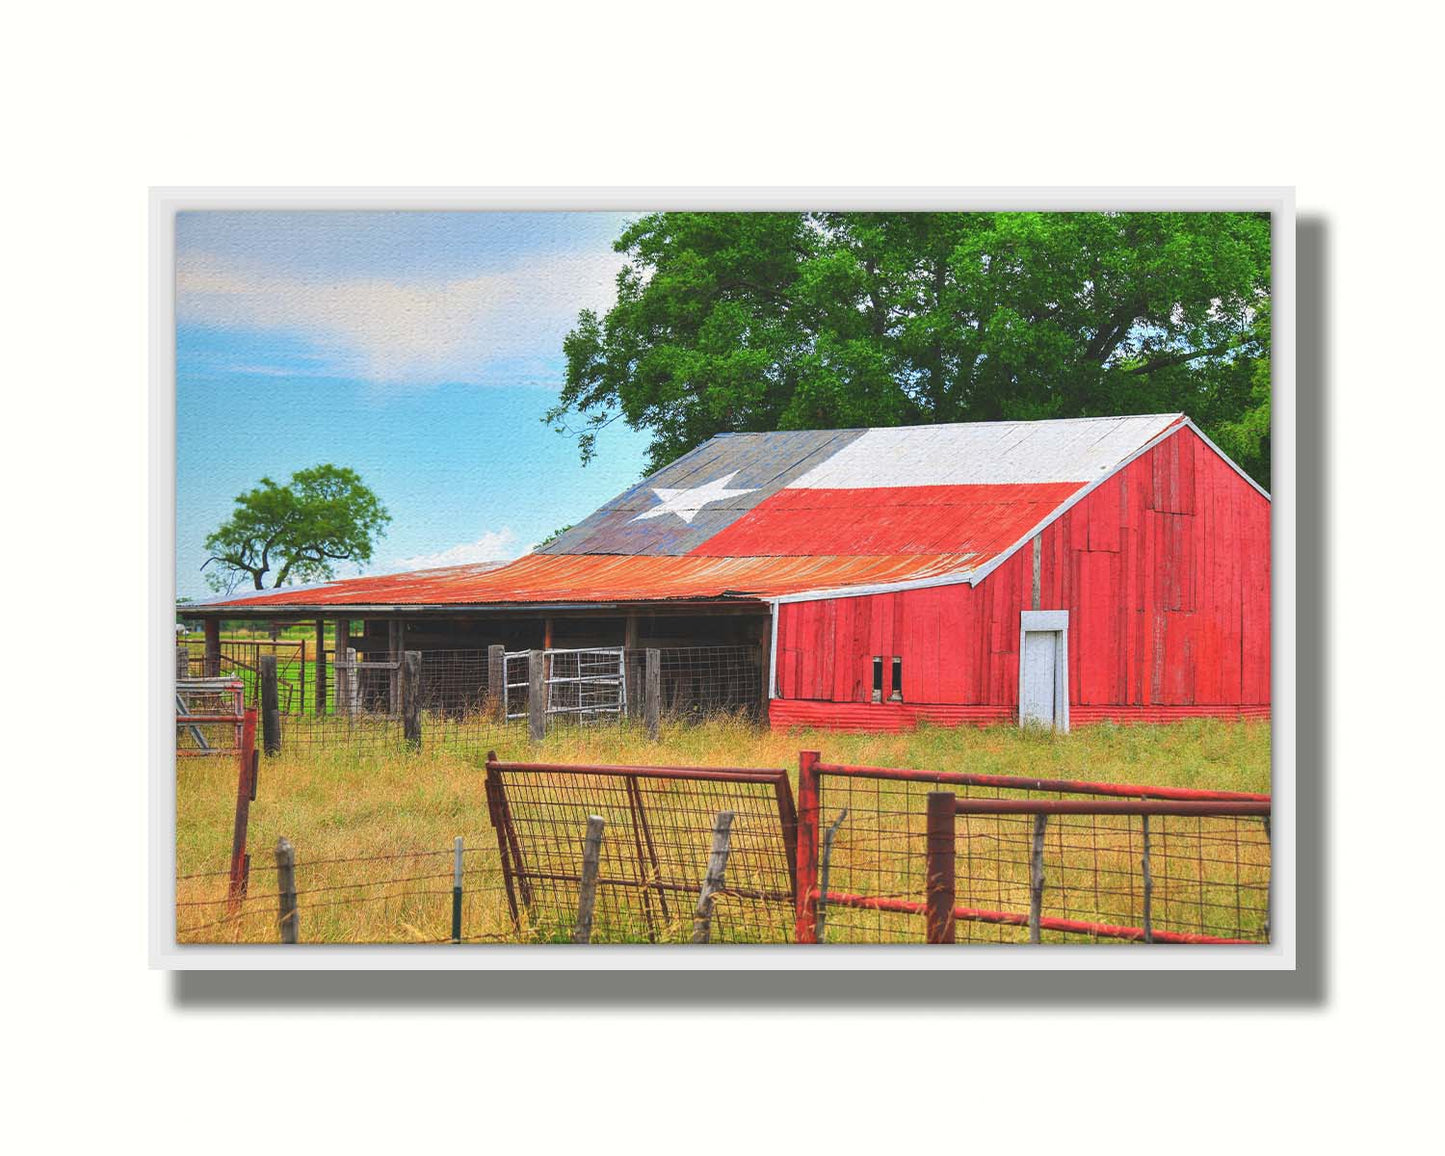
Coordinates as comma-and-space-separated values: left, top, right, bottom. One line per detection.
487, 757, 796, 944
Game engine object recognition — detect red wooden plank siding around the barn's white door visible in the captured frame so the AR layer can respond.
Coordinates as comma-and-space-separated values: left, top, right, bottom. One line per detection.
775, 429, 1270, 724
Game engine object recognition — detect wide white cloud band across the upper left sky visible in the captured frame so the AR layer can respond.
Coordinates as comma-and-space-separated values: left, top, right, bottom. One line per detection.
176, 251, 621, 384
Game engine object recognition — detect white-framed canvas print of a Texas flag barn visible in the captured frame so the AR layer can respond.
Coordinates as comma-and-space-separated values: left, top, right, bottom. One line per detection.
150, 189, 1295, 970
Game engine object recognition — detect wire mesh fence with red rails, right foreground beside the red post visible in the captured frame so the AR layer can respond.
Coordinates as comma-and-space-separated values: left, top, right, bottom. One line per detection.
799, 759, 1270, 942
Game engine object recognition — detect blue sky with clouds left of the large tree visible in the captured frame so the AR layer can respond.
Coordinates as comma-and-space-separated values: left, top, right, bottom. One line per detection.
176, 212, 646, 597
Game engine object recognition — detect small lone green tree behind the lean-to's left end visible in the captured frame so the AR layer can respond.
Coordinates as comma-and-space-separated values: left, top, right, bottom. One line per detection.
201, 465, 392, 594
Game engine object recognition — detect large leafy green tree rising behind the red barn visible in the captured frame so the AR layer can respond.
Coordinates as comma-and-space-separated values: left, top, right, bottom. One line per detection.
546, 212, 1270, 486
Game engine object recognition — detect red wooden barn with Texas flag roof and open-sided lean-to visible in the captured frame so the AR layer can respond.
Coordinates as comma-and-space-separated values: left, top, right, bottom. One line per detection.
184, 413, 1270, 730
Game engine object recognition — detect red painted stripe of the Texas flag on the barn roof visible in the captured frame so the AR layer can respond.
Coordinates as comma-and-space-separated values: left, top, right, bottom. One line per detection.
692, 481, 1084, 566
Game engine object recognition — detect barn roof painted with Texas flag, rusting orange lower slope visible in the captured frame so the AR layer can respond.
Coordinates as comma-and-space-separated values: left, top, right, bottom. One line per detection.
188, 413, 1257, 610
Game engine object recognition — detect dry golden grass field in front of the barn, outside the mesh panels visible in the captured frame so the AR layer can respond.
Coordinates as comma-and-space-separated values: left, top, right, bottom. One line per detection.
176, 720, 1270, 944
